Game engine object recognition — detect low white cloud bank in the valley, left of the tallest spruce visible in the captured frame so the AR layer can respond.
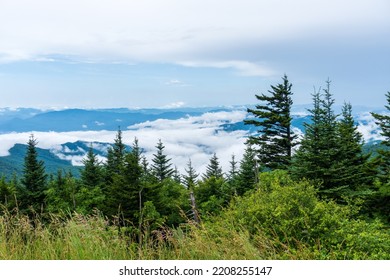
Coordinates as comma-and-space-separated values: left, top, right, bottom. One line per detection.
0, 111, 246, 173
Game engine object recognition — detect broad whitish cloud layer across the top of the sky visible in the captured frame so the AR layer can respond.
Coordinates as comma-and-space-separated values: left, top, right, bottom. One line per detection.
0, 0, 389, 68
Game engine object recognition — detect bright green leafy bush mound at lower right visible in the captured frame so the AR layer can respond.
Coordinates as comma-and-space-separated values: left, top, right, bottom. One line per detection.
222, 171, 390, 259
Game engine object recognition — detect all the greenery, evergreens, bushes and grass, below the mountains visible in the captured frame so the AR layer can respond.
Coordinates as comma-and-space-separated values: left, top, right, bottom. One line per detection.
0, 76, 390, 259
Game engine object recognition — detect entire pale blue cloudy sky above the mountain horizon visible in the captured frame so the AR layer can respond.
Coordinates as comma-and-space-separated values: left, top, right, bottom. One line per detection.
0, 0, 390, 108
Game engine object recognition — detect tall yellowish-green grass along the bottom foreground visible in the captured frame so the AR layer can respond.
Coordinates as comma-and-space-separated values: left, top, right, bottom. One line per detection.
0, 208, 388, 260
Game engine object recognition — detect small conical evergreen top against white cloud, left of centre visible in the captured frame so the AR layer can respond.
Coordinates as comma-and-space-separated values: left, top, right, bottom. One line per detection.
152, 139, 174, 182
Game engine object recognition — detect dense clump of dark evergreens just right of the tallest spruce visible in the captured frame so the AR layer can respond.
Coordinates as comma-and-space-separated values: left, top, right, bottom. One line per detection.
290, 81, 376, 202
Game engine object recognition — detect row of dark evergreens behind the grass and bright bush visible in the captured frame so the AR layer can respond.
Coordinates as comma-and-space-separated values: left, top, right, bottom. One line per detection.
0, 76, 390, 230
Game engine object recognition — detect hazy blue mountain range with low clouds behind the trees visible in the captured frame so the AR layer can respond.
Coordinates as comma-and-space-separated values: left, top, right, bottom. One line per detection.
0, 105, 381, 176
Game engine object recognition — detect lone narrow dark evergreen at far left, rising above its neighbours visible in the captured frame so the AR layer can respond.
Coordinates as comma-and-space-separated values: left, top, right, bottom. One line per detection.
21, 135, 47, 211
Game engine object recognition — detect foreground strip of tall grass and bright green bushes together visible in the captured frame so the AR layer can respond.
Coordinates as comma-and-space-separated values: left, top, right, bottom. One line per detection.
0, 172, 390, 260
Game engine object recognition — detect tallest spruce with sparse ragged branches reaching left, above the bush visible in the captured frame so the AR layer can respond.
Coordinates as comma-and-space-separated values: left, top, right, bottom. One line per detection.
244, 75, 296, 169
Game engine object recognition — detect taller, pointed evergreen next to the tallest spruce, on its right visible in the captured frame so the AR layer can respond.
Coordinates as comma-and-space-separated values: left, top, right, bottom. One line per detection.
291, 80, 342, 197
